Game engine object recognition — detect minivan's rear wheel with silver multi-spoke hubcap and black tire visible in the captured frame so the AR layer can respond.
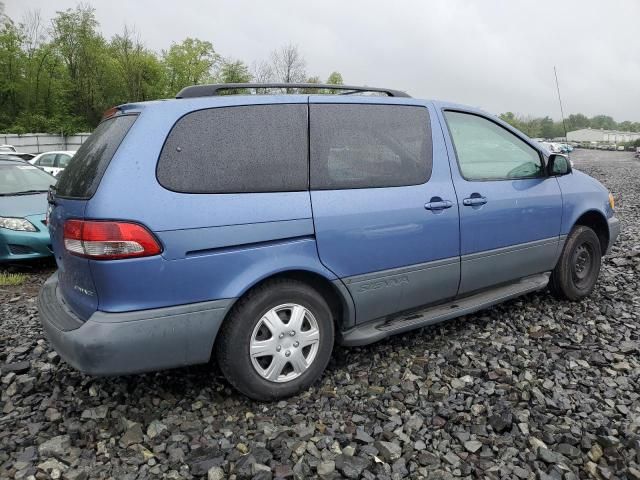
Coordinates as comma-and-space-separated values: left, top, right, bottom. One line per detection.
215, 279, 335, 401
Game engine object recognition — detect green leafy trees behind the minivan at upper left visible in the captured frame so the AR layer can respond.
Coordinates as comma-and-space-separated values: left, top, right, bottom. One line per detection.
0, 3, 342, 134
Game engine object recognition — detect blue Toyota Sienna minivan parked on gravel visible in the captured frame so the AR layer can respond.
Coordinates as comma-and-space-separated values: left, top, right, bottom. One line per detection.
39, 84, 620, 400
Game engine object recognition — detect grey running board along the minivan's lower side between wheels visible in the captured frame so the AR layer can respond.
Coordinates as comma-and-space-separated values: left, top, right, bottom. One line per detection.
341, 273, 550, 347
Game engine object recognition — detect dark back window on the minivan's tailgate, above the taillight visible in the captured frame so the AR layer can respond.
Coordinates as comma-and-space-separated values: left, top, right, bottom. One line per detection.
56, 115, 137, 198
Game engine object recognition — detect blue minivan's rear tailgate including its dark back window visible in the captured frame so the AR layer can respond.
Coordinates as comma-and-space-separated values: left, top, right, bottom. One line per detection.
48, 115, 136, 320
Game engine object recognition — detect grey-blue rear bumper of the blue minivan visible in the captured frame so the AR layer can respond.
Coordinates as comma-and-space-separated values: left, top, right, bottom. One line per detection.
38, 273, 233, 375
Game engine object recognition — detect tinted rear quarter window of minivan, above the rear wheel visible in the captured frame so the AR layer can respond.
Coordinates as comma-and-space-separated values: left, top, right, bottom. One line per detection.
157, 105, 309, 193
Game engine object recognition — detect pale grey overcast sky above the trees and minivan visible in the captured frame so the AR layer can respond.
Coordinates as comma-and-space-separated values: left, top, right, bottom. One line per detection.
4, 0, 640, 121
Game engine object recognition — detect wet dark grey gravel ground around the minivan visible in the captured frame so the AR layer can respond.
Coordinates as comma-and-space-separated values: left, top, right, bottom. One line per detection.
0, 151, 640, 480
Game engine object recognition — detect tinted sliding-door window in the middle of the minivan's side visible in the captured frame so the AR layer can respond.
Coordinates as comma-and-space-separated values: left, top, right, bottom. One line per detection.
310, 104, 432, 190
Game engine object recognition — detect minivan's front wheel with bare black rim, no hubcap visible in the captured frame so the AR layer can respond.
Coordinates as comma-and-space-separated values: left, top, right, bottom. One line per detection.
549, 225, 602, 300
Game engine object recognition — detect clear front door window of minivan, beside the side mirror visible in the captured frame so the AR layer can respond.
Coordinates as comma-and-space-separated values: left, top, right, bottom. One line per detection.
444, 111, 544, 180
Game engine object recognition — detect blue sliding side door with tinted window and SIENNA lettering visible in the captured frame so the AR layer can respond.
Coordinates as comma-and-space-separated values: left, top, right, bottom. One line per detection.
310, 97, 460, 322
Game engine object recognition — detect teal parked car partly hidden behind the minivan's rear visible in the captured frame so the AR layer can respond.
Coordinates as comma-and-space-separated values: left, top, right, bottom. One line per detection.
0, 154, 56, 262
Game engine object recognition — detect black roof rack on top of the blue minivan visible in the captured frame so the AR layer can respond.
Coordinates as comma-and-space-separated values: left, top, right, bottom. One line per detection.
176, 83, 410, 98
